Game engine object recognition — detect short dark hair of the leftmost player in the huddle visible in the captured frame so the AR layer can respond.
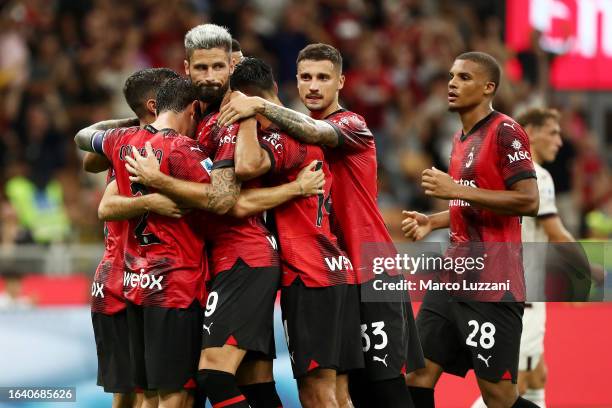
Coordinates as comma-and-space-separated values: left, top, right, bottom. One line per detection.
123, 68, 180, 118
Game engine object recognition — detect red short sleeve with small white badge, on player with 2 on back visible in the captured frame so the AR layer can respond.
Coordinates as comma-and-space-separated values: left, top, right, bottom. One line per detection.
168, 138, 212, 183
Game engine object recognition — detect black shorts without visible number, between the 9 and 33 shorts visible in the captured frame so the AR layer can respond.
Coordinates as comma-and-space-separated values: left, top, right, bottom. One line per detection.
281, 278, 364, 378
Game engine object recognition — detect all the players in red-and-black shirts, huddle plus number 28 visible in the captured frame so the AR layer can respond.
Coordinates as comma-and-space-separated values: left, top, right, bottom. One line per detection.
75, 24, 568, 408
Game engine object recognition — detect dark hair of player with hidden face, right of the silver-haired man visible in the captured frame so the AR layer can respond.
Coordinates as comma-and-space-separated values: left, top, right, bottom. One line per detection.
230, 57, 274, 96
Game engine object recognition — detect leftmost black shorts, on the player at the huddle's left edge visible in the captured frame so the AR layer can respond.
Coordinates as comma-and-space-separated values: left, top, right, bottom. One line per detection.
91, 309, 134, 393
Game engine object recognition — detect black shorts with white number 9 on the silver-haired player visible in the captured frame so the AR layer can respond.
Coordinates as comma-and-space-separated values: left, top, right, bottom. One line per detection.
201, 259, 280, 358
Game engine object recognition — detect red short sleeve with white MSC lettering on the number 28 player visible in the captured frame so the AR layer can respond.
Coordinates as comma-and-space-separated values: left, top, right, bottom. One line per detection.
497, 121, 536, 188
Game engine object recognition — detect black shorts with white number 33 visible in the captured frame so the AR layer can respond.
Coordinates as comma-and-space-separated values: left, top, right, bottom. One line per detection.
359, 274, 425, 381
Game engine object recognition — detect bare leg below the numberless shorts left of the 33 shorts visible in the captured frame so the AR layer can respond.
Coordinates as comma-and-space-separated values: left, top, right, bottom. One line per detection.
298, 368, 338, 408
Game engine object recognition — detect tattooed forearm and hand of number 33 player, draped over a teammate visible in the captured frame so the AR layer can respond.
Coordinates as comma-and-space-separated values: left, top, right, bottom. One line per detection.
217, 95, 339, 147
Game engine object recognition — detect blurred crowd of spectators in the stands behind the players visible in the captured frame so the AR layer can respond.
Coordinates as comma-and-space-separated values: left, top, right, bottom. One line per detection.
0, 0, 612, 247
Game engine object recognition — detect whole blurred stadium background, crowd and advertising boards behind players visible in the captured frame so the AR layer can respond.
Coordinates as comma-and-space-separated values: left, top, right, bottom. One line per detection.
0, 0, 612, 408
